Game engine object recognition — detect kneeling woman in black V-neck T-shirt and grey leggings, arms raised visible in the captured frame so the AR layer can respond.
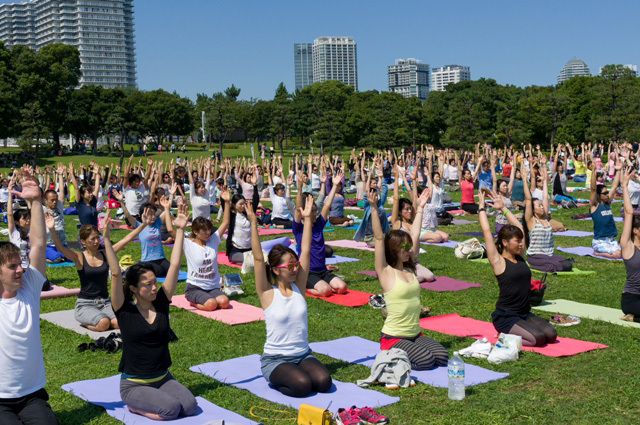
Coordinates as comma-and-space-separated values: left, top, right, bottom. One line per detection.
104, 205, 198, 420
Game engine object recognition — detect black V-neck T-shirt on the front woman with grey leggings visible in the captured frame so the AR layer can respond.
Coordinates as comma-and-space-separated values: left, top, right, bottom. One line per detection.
116, 288, 171, 376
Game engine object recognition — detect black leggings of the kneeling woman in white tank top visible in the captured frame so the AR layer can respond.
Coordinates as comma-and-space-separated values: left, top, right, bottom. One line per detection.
269, 357, 331, 397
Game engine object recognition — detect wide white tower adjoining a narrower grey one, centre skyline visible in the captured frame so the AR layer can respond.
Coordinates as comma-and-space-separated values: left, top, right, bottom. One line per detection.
313, 37, 358, 91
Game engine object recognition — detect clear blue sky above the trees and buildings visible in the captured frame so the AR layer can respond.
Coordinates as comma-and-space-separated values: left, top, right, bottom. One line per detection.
7, 0, 640, 99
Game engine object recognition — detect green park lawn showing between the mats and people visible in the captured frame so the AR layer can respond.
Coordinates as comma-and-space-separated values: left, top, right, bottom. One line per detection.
4, 158, 640, 425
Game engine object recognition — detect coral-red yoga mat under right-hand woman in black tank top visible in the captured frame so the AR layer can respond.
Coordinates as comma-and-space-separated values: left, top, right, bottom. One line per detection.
420, 313, 608, 357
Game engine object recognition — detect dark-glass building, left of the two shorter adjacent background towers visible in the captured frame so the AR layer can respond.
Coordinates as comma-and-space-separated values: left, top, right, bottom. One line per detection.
387, 58, 429, 100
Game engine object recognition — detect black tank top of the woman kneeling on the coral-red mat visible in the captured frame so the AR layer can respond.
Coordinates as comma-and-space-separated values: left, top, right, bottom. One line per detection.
496, 255, 531, 314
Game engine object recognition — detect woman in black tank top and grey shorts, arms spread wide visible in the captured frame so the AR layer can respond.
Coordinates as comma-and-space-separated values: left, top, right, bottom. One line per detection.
45, 211, 147, 332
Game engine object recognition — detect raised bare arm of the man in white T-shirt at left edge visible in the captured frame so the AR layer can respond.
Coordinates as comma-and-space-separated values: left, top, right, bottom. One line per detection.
11, 166, 47, 276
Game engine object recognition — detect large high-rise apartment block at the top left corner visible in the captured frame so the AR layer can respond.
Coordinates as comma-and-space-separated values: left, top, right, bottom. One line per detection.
0, 0, 136, 88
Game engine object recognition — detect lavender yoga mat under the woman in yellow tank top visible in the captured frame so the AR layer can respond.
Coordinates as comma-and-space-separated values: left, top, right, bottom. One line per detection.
309, 336, 509, 388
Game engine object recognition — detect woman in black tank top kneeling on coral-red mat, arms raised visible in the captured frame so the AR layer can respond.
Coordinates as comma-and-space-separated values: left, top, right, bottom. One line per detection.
478, 190, 556, 347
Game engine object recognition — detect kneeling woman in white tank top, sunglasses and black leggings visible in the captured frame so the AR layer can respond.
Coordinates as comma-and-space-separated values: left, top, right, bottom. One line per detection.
246, 197, 332, 397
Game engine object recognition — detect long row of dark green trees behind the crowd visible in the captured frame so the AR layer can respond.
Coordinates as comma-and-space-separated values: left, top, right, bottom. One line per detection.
0, 42, 640, 159
